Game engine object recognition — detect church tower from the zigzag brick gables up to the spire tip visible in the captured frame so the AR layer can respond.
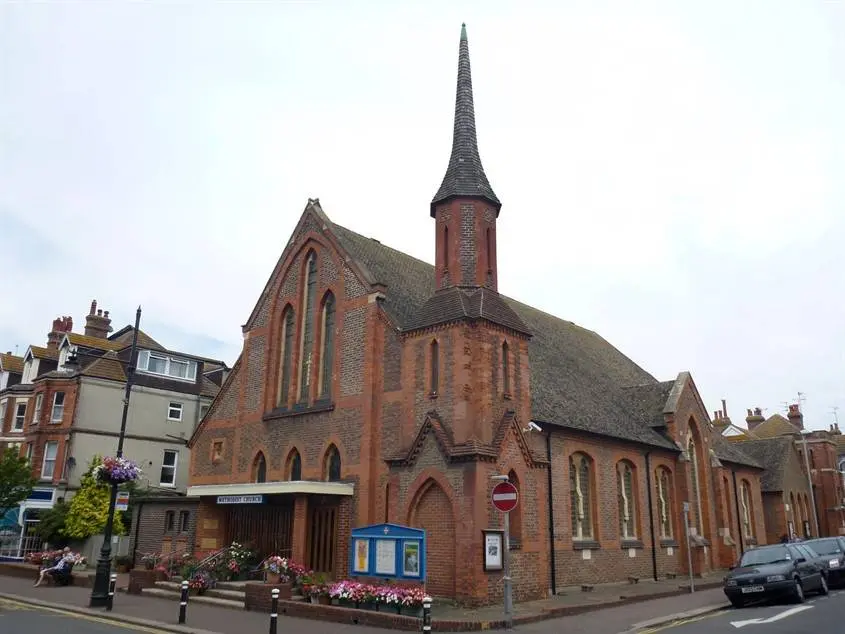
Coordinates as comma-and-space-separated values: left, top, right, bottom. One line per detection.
406, 25, 531, 446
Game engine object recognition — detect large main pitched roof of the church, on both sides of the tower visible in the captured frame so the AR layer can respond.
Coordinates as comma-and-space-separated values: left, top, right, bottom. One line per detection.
329, 221, 677, 450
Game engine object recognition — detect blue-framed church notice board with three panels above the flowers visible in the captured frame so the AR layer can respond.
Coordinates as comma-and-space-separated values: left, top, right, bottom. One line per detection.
349, 524, 426, 581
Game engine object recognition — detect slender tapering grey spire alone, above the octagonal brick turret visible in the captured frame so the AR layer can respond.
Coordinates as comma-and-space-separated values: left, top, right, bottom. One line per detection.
431, 24, 502, 218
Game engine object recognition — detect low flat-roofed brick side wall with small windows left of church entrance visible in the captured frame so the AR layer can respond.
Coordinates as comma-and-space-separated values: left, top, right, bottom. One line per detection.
129, 497, 199, 563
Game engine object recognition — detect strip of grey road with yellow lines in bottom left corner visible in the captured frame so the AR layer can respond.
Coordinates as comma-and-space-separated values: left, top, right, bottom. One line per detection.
0, 599, 171, 634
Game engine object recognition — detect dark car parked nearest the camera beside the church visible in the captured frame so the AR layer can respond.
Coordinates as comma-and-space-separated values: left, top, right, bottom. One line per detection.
724, 544, 828, 608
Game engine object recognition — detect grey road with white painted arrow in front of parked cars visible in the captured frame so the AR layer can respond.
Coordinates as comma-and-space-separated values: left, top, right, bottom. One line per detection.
635, 590, 845, 634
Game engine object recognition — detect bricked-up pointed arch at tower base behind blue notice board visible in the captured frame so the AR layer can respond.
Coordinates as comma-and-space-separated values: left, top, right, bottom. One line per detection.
408, 480, 455, 597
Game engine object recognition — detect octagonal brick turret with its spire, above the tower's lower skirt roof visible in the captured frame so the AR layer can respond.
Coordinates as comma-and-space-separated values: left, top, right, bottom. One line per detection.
431, 24, 502, 291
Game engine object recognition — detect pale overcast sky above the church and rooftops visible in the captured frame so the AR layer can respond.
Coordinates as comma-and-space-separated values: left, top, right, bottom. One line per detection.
0, 0, 845, 428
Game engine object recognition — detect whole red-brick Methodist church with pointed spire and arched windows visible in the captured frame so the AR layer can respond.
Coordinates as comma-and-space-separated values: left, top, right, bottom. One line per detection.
189, 24, 766, 604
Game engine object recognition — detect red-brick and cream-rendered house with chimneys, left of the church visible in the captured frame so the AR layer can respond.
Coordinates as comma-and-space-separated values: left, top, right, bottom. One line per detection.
0, 300, 229, 556
